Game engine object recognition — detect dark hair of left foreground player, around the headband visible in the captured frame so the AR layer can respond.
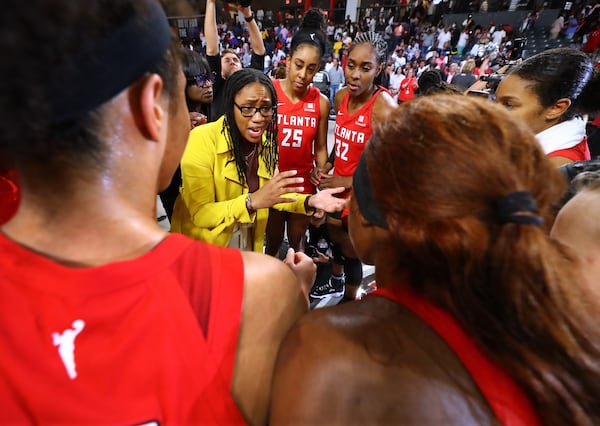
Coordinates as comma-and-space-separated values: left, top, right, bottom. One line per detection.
0, 0, 179, 192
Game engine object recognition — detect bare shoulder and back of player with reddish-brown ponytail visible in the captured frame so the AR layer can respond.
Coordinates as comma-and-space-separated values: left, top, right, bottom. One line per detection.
273, 297, 492, 424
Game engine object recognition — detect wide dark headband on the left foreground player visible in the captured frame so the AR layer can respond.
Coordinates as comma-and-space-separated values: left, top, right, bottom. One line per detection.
47, 0, 171, 124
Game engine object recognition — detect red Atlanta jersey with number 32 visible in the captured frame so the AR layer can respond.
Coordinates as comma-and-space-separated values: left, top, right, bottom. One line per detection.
333, 87, 383, 180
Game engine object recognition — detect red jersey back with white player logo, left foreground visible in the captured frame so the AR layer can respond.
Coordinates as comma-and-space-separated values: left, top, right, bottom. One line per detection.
0, 234, 244, 425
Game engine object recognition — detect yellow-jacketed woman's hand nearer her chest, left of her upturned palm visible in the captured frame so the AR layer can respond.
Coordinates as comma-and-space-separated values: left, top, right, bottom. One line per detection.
250, 170, 304, 209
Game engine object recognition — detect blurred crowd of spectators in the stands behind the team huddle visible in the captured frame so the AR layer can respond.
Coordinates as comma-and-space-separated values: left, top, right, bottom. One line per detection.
183, 1, 600, 105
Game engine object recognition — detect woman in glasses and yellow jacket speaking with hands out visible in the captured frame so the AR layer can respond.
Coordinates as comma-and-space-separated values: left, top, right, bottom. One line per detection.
171, 69, 344, 252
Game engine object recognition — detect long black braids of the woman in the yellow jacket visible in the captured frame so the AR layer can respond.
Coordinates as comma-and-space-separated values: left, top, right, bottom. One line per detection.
221, 68, 277, 184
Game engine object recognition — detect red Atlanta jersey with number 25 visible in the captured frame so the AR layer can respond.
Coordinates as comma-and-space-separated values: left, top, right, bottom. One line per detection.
273, 80, 321, 194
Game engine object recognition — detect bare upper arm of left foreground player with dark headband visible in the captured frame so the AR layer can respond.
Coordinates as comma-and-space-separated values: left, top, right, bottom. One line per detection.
231, 252, 307, 425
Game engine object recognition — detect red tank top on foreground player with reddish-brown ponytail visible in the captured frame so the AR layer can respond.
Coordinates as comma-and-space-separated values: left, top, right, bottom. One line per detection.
368, 286, 541, 426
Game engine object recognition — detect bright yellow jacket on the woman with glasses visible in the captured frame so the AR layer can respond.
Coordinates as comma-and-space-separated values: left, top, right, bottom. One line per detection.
171, 116, 309, 252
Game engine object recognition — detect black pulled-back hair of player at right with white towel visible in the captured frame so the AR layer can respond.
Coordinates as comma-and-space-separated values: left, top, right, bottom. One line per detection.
510, 47, 600, 121
